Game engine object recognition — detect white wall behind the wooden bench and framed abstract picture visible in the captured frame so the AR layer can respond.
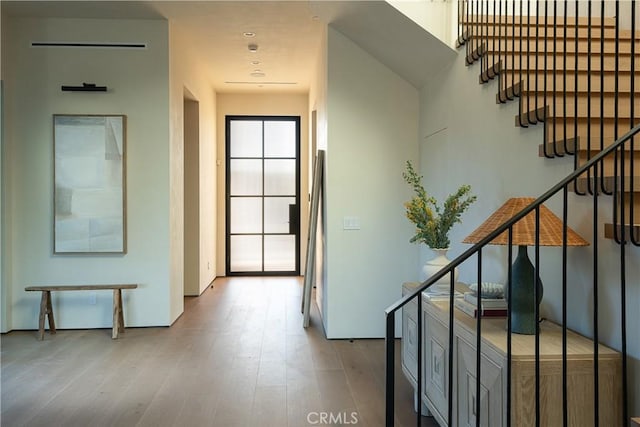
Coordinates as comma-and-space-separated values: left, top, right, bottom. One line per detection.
2, 18, 171, 330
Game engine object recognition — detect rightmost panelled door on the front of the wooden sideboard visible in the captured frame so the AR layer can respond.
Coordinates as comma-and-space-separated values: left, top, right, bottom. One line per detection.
456, 335, 504, 427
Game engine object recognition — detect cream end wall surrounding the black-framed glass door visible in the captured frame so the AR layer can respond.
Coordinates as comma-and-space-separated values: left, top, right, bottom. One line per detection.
216, 93, 311, 276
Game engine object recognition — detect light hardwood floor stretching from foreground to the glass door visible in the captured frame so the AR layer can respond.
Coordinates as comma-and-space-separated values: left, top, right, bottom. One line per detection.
0, 277, 436, 427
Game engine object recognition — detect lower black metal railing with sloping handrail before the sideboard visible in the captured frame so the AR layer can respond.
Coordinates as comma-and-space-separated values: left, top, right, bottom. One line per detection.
385, 125, 640, 427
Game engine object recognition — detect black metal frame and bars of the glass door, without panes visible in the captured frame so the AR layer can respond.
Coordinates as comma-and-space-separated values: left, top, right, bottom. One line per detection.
224, 115, 302, 276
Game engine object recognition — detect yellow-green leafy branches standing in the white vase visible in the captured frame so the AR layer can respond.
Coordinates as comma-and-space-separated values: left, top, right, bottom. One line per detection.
402, 161, 476, 249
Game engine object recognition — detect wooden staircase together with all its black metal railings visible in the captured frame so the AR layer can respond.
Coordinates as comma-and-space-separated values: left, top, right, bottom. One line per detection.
386, 0, 640, 426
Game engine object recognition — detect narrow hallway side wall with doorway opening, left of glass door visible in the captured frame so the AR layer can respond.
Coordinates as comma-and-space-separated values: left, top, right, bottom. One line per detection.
170, 24, 218, 310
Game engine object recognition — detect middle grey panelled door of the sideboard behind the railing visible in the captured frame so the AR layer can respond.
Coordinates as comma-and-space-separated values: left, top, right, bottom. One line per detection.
422, 304, 449, 426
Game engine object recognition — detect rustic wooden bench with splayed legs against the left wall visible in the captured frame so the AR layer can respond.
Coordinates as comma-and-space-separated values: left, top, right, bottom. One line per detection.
24, 285, 138, 341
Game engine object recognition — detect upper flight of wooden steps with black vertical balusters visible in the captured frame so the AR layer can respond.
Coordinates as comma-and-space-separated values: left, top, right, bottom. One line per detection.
458, 1, 640, 245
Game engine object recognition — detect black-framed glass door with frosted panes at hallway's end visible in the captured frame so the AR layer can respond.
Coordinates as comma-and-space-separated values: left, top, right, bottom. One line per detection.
225, 116, 300, 275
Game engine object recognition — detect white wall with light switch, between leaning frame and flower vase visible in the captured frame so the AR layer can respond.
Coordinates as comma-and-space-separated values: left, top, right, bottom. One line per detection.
324, 27, 418, 338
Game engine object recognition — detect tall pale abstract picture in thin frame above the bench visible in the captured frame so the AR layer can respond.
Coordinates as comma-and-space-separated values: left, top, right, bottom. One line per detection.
53, 114, 126, 254
